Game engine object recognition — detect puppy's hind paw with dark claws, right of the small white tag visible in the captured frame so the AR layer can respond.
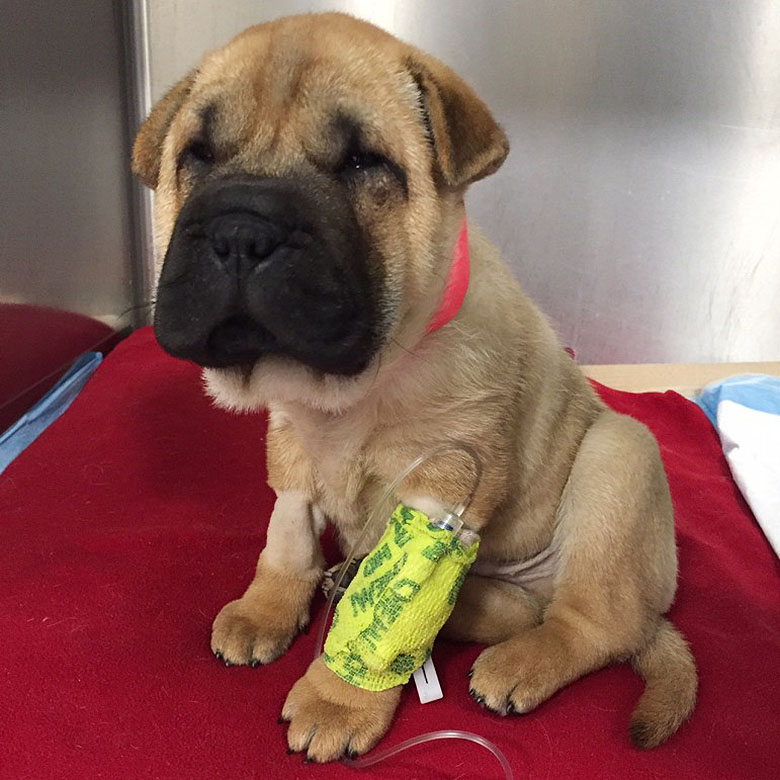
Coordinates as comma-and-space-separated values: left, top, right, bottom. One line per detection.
469, 636, 566, 715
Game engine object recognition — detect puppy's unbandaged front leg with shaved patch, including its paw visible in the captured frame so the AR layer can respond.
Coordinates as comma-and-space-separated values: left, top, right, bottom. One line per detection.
211, 490, 322, 666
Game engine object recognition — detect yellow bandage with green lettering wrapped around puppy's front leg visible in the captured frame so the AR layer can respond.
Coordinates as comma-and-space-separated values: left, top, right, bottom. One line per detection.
323, 504, 479, 691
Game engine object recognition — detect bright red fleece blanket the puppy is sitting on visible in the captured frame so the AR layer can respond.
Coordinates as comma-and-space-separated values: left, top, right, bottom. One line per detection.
0, 329, 780, 780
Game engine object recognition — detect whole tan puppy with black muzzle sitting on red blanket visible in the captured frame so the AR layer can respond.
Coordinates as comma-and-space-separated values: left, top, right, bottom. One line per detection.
134, 14, 697, 761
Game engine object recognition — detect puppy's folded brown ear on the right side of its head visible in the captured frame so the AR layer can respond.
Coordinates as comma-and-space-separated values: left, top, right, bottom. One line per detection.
407, 52, 509, 187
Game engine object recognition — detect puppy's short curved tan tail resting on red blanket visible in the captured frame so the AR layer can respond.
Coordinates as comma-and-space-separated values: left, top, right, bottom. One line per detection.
630, 619, 698, 748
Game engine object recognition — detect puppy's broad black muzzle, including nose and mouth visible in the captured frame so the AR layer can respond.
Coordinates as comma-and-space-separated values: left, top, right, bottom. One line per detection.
154, 176, 381, 376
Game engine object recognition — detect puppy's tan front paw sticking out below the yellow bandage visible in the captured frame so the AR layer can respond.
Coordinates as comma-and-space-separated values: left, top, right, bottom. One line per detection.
282, 658, 402, 762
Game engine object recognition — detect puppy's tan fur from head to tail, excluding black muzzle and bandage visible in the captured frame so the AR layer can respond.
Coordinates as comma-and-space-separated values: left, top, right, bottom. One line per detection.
134, 14, 696, 761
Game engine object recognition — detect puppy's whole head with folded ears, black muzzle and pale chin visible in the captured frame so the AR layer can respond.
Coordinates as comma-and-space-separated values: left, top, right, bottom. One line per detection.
133, 14, 508, 408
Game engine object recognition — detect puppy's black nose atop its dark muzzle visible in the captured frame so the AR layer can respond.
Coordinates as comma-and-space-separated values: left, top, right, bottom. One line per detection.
207, 212, 284, 274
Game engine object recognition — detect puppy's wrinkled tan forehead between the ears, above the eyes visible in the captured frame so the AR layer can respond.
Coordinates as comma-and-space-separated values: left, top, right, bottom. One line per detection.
177, 23, 421, 165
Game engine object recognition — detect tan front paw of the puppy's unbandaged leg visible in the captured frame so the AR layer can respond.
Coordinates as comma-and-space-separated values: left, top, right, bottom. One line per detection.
211, 570, 317, 666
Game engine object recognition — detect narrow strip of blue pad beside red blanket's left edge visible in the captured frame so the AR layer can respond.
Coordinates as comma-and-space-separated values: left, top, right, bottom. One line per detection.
0, 352, 103, 474
